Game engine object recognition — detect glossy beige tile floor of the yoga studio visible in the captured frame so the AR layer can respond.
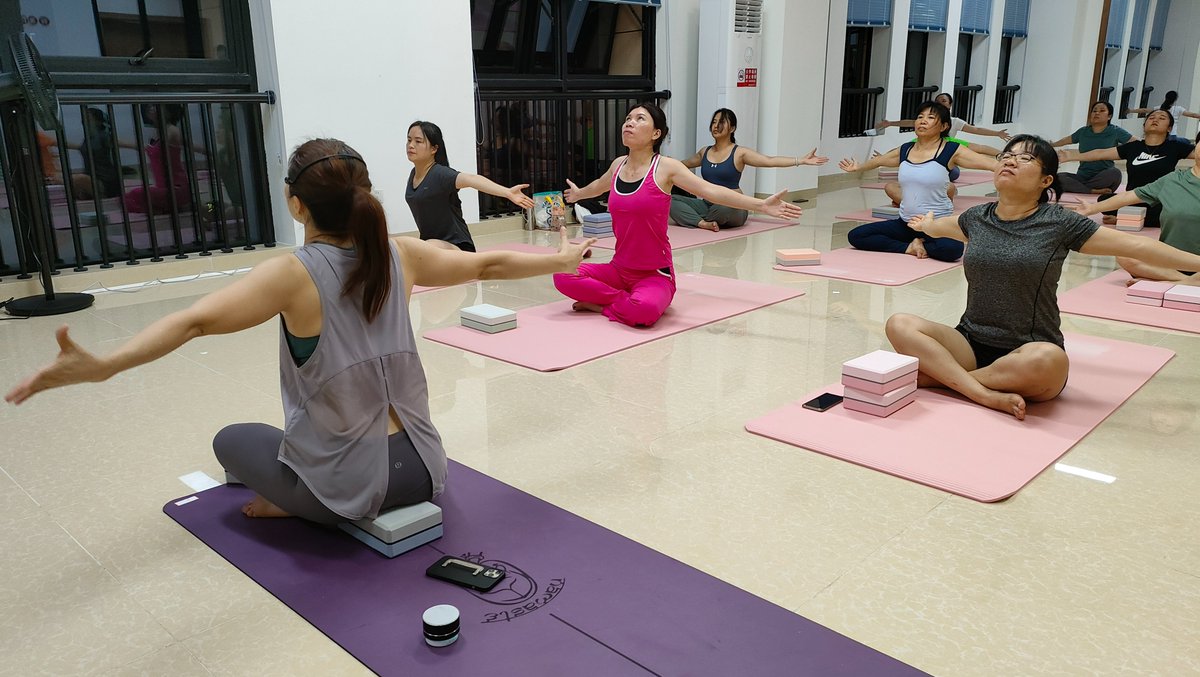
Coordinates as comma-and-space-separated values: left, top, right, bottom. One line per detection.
0, 177, 1200, 676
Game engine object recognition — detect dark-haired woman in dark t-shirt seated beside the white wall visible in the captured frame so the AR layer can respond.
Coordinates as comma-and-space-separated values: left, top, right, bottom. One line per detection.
404, 120, 533, 252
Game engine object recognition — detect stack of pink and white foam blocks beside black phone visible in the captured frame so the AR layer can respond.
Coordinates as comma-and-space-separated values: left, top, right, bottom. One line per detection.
841, 351, 917, 417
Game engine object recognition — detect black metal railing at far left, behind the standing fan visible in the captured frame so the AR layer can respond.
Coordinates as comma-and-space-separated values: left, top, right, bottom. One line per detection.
0, 92, 275, 278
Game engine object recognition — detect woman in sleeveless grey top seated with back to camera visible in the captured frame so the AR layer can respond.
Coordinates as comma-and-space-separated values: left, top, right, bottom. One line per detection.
5, 139, 594, 523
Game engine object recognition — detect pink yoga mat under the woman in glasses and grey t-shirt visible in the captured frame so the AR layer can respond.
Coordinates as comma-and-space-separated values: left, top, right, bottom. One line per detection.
746, 333, 1176, 503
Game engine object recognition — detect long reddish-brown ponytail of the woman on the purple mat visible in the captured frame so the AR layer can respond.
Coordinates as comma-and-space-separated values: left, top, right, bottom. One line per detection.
342, 185, 391, 322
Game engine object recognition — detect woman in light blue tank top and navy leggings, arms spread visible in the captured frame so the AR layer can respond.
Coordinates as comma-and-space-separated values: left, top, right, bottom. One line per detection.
838, 101, 996, 260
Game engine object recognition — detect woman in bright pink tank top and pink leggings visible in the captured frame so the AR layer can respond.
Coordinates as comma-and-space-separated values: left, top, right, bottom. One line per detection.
554, 103, 800, 326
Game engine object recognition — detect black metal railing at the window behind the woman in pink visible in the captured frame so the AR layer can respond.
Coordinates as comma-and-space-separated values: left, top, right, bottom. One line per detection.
475, 91, 671, 218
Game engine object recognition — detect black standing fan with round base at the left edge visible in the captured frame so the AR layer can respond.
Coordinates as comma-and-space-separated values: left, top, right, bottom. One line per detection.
0, 34, 94, 317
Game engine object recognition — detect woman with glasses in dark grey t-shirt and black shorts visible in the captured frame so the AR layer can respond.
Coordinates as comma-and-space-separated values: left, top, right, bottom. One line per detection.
887, 134, 1200, 419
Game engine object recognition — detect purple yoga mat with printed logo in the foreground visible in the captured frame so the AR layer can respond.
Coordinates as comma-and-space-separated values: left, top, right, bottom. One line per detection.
163, 461, 924, 677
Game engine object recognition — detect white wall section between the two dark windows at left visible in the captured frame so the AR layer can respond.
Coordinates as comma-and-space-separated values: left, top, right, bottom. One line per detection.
251, 0, 479, 242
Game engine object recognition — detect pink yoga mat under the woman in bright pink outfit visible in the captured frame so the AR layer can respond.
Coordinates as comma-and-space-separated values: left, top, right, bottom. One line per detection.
425, 272, 804, 371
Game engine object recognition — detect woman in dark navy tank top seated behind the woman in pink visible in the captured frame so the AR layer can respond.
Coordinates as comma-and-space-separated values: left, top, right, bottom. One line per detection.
671, 108, 829, 232
